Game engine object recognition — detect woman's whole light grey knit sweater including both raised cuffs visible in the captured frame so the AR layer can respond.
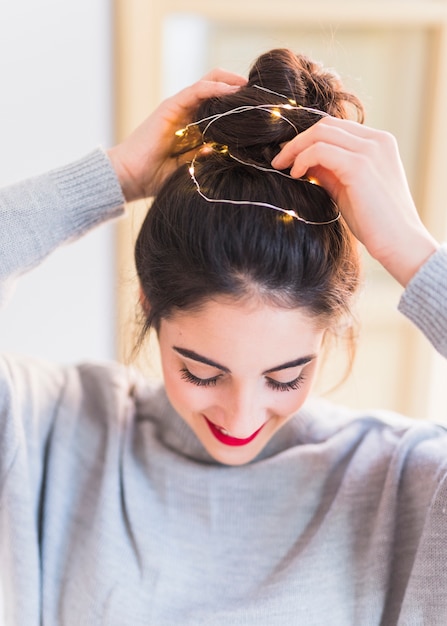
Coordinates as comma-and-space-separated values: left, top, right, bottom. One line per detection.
0, 150, 447, 626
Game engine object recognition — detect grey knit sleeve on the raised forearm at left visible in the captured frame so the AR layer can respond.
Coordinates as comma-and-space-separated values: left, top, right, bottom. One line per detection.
0, 148, 124, 303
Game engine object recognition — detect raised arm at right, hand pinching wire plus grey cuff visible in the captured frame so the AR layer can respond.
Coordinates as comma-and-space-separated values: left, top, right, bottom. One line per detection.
272, 117, 447, 357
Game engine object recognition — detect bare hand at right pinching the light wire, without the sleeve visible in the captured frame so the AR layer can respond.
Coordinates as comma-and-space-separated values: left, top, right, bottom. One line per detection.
272, 117, 438, 286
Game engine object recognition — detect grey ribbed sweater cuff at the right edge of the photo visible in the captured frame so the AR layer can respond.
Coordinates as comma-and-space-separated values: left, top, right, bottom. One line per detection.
399, 244, 447, 357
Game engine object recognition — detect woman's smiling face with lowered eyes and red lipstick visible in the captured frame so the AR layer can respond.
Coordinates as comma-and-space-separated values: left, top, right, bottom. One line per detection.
159, 298, 325, 465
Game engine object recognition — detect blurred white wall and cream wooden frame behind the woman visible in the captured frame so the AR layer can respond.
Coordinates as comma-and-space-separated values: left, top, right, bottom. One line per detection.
0, 0, 447, 421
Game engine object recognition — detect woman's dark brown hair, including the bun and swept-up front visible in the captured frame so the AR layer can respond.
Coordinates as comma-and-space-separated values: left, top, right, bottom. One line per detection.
135, 49, 363, 336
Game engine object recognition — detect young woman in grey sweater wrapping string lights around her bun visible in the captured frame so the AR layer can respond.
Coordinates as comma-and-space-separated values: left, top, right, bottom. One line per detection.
0, 50, 447, 626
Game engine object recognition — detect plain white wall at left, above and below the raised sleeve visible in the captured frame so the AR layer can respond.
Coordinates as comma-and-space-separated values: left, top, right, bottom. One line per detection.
0, 0, 114, 362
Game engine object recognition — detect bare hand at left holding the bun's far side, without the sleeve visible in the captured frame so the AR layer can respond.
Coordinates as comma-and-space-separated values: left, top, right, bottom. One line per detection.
108, 69, 247, 201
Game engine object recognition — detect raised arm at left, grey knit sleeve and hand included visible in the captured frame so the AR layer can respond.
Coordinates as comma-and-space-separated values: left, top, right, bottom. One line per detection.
0, 70, 245, 299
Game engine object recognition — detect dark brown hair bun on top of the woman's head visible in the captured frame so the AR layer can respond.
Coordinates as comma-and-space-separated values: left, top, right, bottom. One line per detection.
193, 49, 363, 164
